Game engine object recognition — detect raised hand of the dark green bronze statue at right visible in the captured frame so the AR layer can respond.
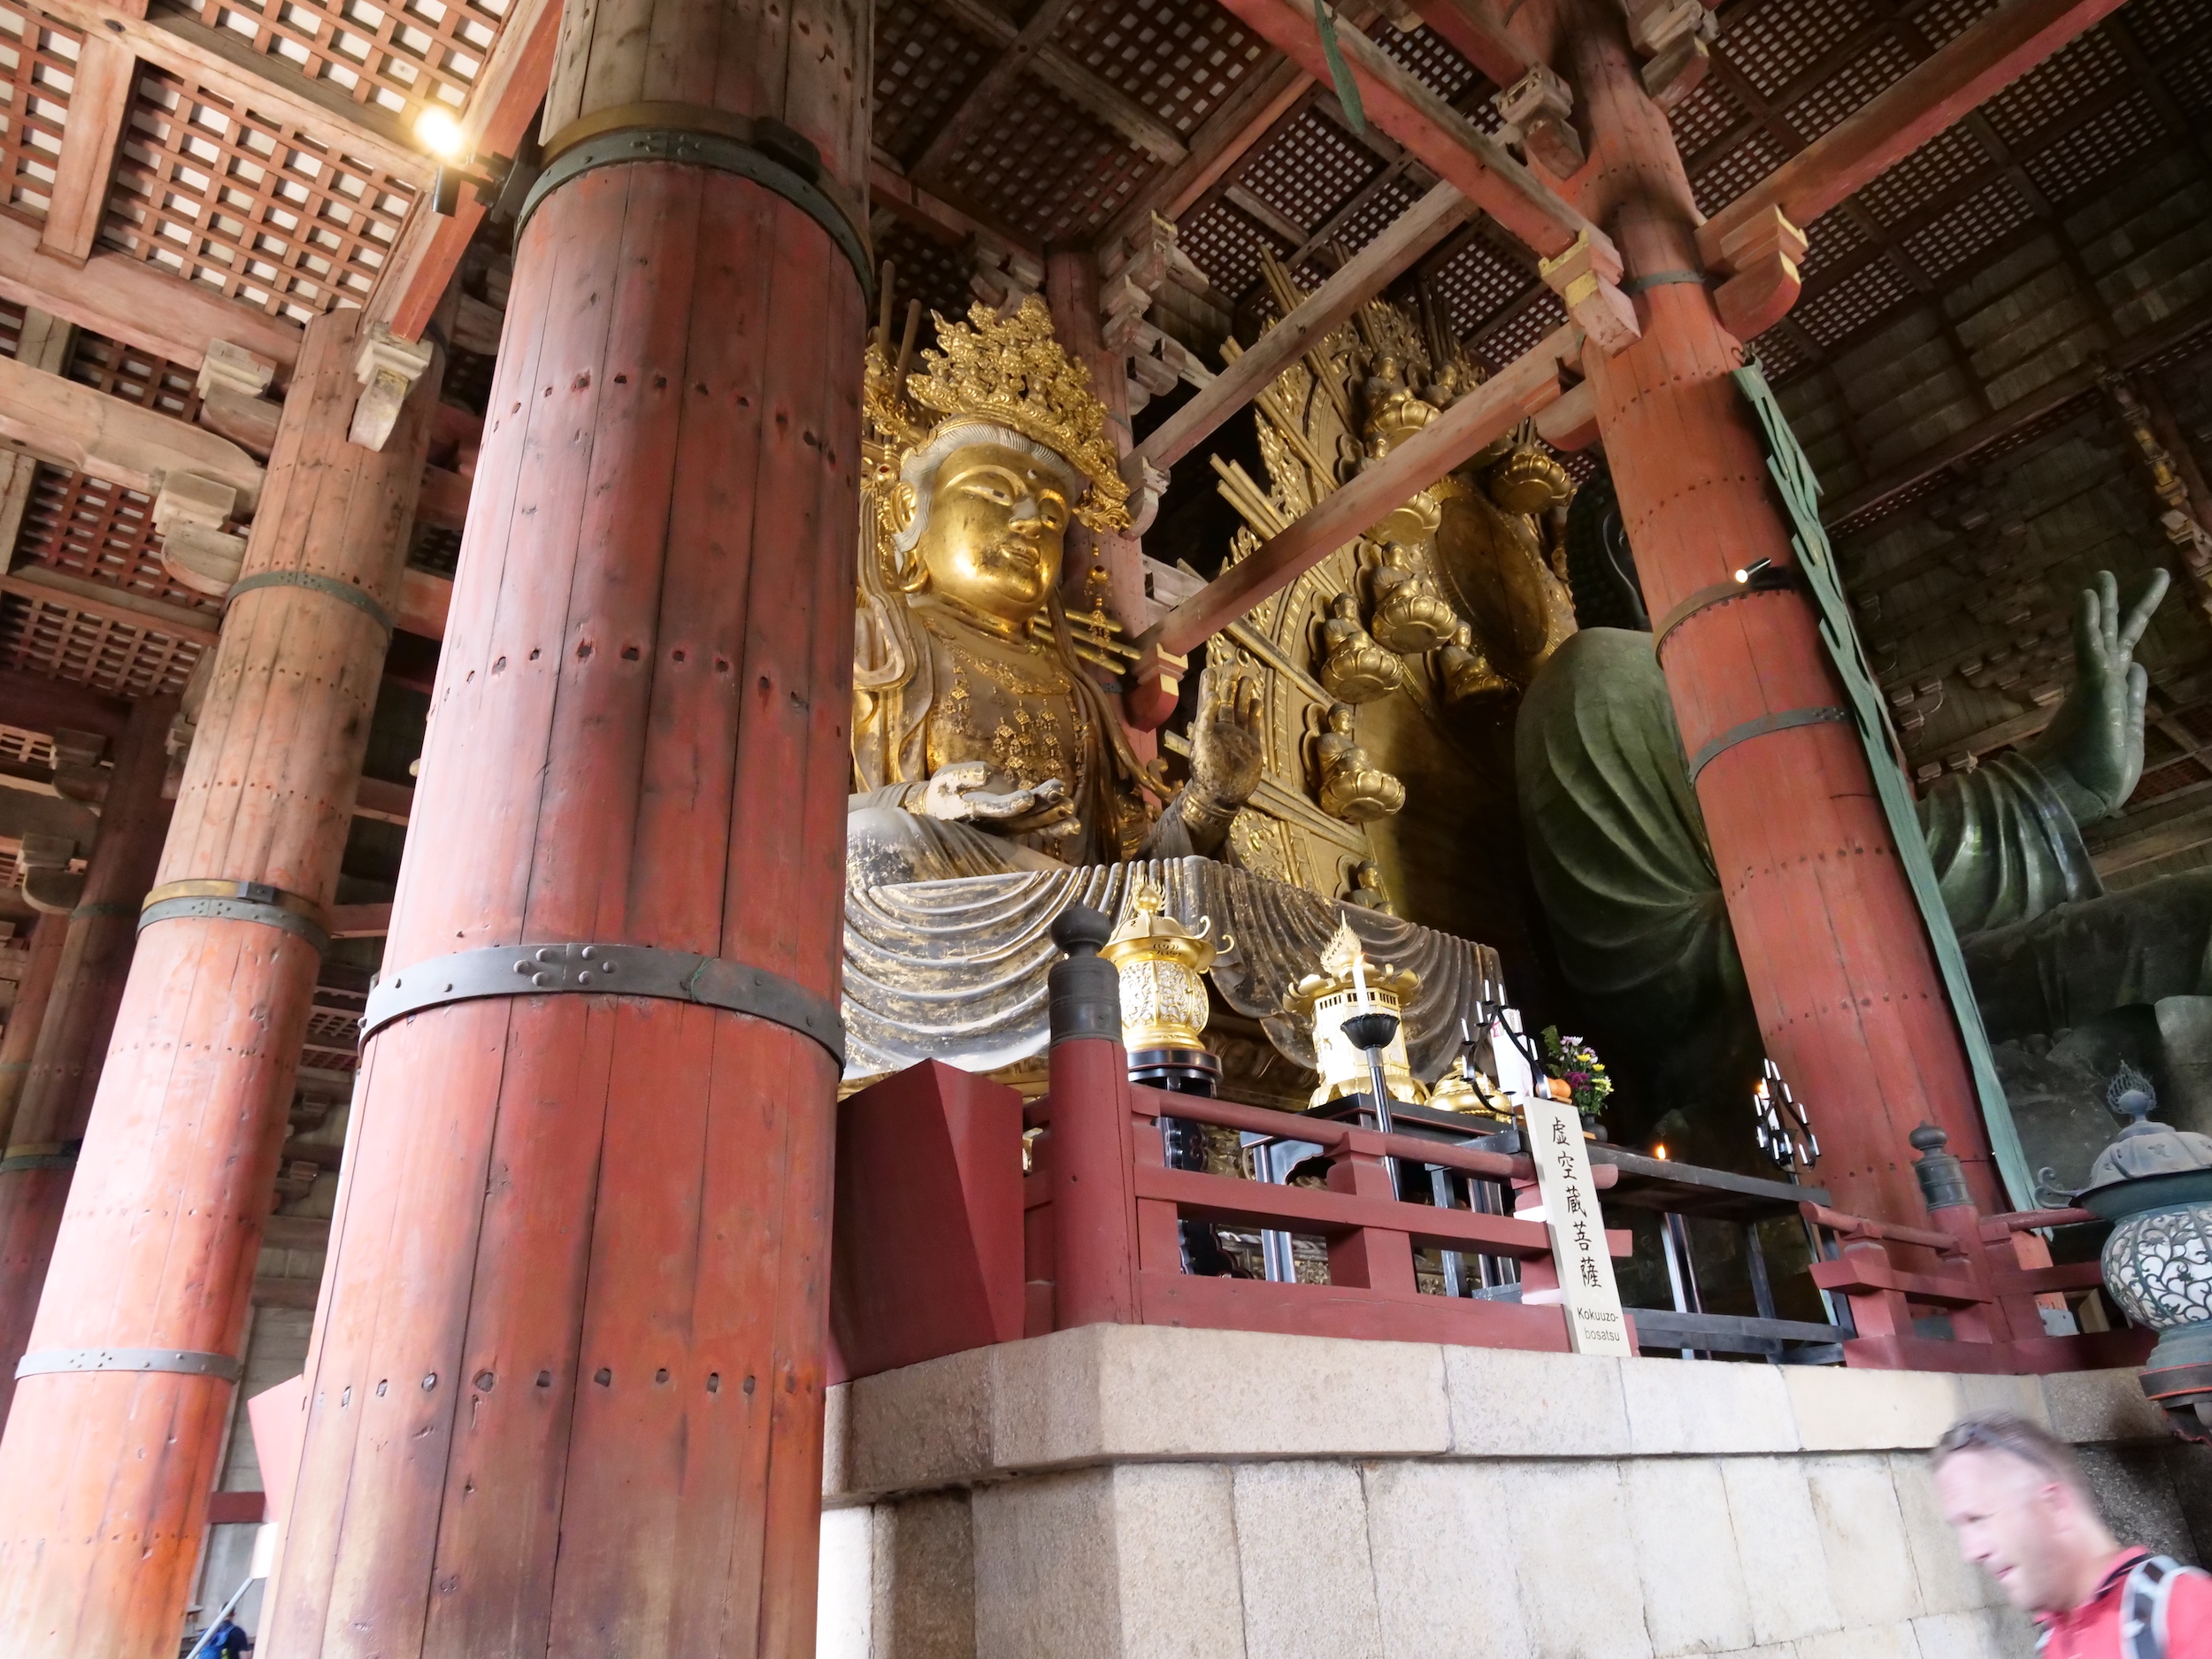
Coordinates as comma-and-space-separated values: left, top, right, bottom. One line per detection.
2029, 571, 2170, 823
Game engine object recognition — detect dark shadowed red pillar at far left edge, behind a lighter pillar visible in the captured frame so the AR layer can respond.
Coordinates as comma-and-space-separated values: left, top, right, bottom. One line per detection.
0, 697, 177, 1425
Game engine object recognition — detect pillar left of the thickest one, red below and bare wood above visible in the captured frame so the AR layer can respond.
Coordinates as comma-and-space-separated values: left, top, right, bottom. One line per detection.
0, 312, 436, 1659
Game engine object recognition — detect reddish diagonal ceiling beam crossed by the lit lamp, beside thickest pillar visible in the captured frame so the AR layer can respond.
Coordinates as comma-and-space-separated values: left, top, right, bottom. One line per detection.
365, 0, 560, 341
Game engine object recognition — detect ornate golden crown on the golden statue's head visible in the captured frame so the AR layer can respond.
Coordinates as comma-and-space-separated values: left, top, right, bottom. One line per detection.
905, 295, 1128, 531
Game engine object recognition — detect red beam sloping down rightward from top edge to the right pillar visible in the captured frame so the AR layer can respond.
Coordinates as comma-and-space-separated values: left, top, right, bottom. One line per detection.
1228, 0, 1593, 261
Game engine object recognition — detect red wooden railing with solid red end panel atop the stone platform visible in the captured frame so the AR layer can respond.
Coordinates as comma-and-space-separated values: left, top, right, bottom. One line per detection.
832, 1035, 2153, 1376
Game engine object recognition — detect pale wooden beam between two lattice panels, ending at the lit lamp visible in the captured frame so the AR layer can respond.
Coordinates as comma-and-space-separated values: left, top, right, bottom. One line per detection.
40, 0, 438, 188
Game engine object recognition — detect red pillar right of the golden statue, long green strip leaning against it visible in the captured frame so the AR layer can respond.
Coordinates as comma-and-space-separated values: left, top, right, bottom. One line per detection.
1560, 0, 2004, 1221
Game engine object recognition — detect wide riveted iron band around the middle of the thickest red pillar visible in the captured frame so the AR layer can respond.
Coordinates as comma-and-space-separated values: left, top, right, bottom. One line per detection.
361, 945, 845, 1071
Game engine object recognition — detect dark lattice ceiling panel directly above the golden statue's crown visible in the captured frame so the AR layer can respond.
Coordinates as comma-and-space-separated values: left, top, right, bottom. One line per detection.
942, 82, 1159, 242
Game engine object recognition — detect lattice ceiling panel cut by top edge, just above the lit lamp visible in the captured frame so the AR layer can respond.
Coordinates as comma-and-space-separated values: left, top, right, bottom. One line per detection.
184, 0, 511, 124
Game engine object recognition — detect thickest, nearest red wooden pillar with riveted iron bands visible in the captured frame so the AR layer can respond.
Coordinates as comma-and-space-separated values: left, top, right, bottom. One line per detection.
264, 0, 870, 1659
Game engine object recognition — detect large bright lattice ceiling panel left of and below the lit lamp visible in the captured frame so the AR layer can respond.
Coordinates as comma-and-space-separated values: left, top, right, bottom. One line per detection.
100, 65, 416, 323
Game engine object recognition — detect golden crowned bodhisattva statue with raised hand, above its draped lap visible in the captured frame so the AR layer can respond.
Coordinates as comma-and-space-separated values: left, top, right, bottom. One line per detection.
848, 296, 1261, 887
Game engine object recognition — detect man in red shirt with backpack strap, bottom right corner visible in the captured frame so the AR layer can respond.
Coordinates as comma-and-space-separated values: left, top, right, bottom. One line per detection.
1932, 1411, 2212, 1659
